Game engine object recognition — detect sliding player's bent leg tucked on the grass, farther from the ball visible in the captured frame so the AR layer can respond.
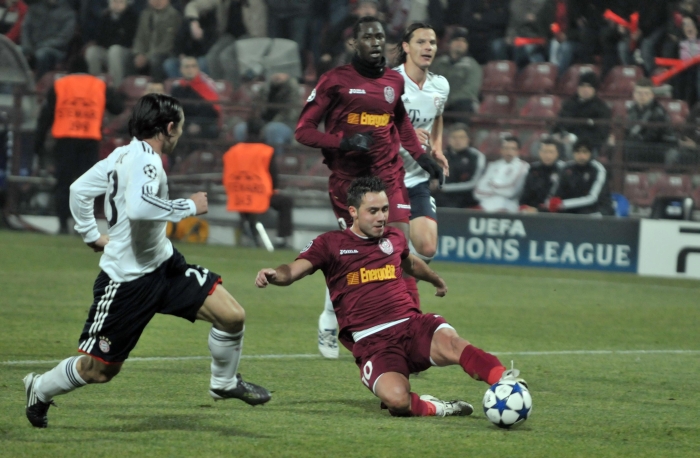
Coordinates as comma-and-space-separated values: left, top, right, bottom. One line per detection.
374, 372, 474, 417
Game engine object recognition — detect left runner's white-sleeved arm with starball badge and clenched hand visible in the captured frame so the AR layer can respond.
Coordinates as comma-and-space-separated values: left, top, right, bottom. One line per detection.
126, 154, 201, 222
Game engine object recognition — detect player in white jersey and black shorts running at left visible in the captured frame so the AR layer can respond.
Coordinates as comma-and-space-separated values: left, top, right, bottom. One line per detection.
24, 94, 270, 428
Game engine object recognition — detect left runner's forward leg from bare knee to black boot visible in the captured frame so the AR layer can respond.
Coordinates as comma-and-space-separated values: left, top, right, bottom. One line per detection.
197, 285, 272, 406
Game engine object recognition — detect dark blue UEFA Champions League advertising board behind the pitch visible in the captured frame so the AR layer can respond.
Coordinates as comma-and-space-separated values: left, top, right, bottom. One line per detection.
435, 208, 639, 272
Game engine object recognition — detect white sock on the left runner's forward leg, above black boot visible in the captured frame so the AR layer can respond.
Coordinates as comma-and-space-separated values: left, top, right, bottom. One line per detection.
209, 326, 245, 389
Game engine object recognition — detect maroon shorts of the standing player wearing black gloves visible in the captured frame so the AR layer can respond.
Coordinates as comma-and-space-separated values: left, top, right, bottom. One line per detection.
328, 176, 411, 227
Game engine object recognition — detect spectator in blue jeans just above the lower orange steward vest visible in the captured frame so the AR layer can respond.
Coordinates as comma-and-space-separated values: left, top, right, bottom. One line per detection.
235, 73, 301, 153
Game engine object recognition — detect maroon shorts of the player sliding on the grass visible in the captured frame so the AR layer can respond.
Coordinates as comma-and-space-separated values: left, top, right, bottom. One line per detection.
352, 313, 449, 393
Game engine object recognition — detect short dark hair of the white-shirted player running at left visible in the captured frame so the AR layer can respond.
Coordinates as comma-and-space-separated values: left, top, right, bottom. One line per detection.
129, 94, 182, 140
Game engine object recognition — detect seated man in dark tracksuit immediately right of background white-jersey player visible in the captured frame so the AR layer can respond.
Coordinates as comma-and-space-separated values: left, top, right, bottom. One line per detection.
433, 123, 486, 208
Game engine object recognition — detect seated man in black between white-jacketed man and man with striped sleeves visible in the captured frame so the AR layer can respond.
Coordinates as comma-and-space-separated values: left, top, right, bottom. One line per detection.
520, 138, 565, 213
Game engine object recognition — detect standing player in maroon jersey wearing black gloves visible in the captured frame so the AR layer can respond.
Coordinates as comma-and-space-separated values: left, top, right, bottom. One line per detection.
295, 16, 447, 358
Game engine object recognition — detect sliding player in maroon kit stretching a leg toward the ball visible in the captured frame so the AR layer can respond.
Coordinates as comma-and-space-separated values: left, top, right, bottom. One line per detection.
255, 177, 521, 416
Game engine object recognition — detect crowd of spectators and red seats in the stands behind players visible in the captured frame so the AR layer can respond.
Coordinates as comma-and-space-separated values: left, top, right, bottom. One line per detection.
0, 0, 700, 213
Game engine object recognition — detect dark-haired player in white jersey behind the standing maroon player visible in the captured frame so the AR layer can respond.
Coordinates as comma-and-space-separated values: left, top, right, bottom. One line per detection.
394, 22, 450, 304
